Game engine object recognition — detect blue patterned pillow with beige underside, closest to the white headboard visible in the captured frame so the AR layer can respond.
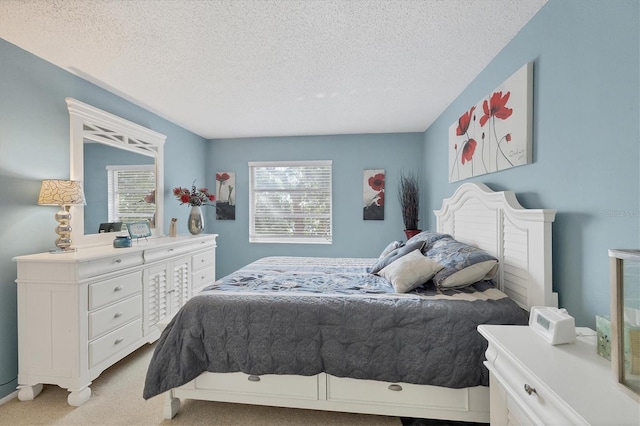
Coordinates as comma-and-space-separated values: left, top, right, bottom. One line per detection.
425, 236, 498, 289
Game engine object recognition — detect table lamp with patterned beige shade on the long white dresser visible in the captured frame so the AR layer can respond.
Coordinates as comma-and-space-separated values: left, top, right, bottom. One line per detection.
38, 179, 86, 253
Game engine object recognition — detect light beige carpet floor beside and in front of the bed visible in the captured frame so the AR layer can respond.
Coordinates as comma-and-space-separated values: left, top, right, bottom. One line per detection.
0, 345, 402, 426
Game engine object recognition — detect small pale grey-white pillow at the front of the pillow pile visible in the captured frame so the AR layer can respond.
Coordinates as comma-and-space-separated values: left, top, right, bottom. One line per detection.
379, 249, 443, 293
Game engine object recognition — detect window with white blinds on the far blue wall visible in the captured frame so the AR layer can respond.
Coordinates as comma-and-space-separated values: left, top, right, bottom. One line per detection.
249, 161, 331, 244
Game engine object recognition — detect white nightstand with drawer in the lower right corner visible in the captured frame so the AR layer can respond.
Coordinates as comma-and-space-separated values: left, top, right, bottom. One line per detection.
478, 325, 640, 425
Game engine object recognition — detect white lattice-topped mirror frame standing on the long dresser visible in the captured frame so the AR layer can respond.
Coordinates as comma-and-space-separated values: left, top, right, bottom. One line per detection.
65, 98, 167, 247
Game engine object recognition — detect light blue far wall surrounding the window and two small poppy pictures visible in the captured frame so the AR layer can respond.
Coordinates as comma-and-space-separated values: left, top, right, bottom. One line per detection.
206, 133, 428, 277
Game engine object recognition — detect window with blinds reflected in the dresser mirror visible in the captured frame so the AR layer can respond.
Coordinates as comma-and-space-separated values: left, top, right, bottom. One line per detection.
107, 164, 156, 227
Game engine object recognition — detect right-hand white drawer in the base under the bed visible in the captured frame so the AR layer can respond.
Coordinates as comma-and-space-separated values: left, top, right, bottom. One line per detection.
327, 375, 469, 411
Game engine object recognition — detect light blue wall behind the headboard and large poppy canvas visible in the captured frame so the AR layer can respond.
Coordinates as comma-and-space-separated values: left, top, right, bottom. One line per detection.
424, 0, 640, 327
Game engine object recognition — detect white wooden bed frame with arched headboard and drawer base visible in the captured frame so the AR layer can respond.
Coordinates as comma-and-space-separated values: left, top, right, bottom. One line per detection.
164, 183, 557, 423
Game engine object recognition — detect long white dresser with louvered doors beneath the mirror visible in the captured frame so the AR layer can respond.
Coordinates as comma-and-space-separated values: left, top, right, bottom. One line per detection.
14, 234, 217, 406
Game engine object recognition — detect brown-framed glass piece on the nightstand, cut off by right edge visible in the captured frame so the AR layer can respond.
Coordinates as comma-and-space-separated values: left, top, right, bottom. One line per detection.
609, 249, 640, 402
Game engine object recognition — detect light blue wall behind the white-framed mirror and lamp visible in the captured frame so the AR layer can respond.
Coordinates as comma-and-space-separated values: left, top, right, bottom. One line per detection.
0, 39, 208, 398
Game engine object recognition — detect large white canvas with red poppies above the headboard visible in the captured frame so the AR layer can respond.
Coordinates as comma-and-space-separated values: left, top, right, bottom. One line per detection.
448, 62, 533, 182
